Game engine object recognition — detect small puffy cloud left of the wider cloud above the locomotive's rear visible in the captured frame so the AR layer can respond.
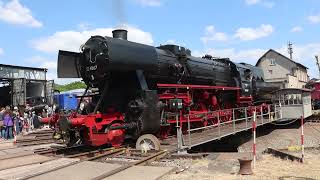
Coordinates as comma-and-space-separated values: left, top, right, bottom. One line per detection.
200, 25, 228, 44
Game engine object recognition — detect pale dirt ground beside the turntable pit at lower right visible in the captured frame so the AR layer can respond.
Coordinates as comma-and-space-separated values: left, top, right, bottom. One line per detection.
161, 123, 320, 180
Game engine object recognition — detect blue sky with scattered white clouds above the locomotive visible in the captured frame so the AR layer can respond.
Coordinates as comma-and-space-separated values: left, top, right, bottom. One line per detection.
0, 0, 320, 84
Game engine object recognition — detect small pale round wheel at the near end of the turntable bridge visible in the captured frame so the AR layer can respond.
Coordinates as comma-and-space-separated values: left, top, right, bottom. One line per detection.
136, 134, 160, 151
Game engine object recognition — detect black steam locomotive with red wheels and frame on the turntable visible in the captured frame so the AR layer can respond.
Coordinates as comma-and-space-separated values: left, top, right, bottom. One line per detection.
58, 29, 277, 148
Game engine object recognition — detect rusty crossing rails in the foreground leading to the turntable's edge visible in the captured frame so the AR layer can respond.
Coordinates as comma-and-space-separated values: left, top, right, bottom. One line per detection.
16, 147, 167, 180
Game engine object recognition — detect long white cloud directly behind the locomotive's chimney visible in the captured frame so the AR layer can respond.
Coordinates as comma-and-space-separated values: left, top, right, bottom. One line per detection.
32, 25, 153, 53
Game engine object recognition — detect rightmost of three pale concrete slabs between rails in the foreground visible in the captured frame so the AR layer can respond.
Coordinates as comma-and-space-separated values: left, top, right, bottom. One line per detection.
105, 166, 175, 180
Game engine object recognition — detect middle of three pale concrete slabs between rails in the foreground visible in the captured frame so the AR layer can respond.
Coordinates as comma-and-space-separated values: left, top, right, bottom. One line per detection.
31, 161, 120, 180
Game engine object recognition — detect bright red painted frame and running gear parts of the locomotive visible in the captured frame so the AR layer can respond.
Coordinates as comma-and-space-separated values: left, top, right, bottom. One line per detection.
43, 84, 267, 147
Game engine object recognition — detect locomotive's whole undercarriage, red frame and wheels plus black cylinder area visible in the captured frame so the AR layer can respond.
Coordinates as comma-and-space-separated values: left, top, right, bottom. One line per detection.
55, 73, 268, 148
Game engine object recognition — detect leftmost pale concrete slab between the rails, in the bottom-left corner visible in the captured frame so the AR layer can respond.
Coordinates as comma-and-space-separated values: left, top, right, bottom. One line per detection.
0, 158, 79, 179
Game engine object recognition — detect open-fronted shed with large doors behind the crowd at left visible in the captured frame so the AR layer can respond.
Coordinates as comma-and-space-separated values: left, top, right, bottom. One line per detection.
0, 64, 54, 107
